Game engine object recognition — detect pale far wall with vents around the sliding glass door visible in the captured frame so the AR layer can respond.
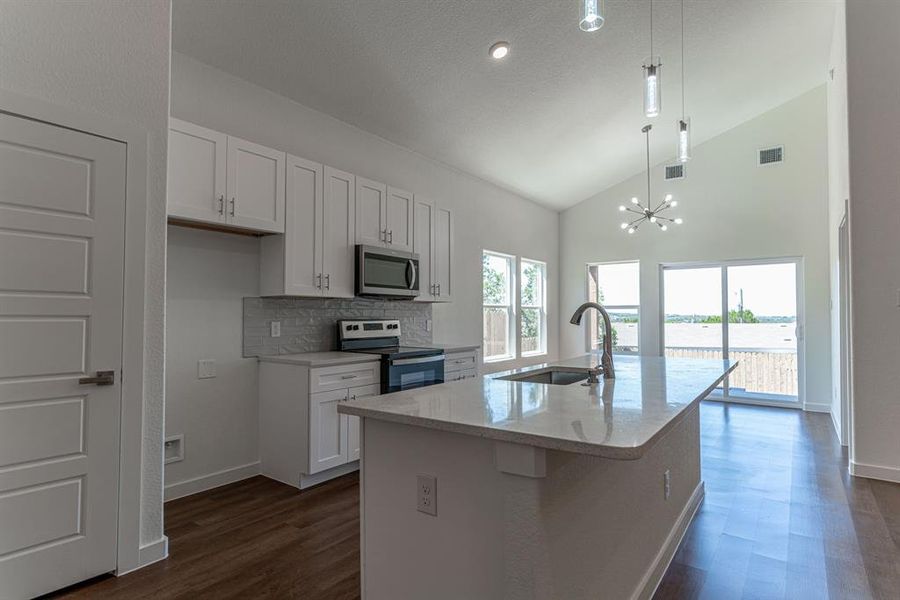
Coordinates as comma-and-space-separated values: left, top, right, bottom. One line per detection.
560, 86, 832, 410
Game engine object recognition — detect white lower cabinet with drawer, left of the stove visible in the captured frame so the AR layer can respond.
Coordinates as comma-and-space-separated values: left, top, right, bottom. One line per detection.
259, 360, 381, 488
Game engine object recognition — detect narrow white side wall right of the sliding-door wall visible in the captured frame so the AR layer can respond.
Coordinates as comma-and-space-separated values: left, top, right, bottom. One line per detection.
826, 3, 850, 444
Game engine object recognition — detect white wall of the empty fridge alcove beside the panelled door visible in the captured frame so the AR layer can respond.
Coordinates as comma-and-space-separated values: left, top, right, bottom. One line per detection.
165, 226, 259, 497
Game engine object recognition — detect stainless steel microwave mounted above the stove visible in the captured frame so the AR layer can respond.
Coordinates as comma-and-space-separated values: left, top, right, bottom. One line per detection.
356, 245, 419, 299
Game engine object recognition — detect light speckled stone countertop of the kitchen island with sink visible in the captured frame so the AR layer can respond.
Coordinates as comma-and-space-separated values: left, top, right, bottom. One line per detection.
338, 354, 737, 460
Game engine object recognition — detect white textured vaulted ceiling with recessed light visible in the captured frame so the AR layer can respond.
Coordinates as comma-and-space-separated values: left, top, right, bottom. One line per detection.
173, 0, 835, 209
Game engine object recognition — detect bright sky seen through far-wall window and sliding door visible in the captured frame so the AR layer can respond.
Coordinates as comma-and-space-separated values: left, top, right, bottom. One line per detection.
598, 263, 797, 317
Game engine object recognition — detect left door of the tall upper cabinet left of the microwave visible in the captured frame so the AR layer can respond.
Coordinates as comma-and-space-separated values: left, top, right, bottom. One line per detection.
284, 156, 325, 296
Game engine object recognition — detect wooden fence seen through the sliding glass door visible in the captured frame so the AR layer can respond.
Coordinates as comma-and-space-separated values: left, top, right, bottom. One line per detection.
666, 348, 797, 396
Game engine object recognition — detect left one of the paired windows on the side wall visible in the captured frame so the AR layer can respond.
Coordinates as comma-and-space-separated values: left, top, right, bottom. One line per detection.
481, 251, 516, 362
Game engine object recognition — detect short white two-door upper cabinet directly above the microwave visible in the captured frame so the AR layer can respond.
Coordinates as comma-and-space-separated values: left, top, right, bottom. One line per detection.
356, 177, 414, 252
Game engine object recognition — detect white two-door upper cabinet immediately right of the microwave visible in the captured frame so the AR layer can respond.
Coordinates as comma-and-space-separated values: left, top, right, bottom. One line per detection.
413, 198, 455, 302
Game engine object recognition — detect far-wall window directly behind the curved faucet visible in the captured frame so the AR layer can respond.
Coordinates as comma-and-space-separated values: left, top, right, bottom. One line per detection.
585, 261, 641, 354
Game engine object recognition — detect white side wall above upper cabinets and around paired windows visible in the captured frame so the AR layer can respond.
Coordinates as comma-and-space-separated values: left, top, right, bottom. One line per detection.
172, 53, 559, 367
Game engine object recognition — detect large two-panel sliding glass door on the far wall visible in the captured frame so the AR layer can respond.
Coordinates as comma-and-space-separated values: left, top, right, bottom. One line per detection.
662, 260, 800, 404
